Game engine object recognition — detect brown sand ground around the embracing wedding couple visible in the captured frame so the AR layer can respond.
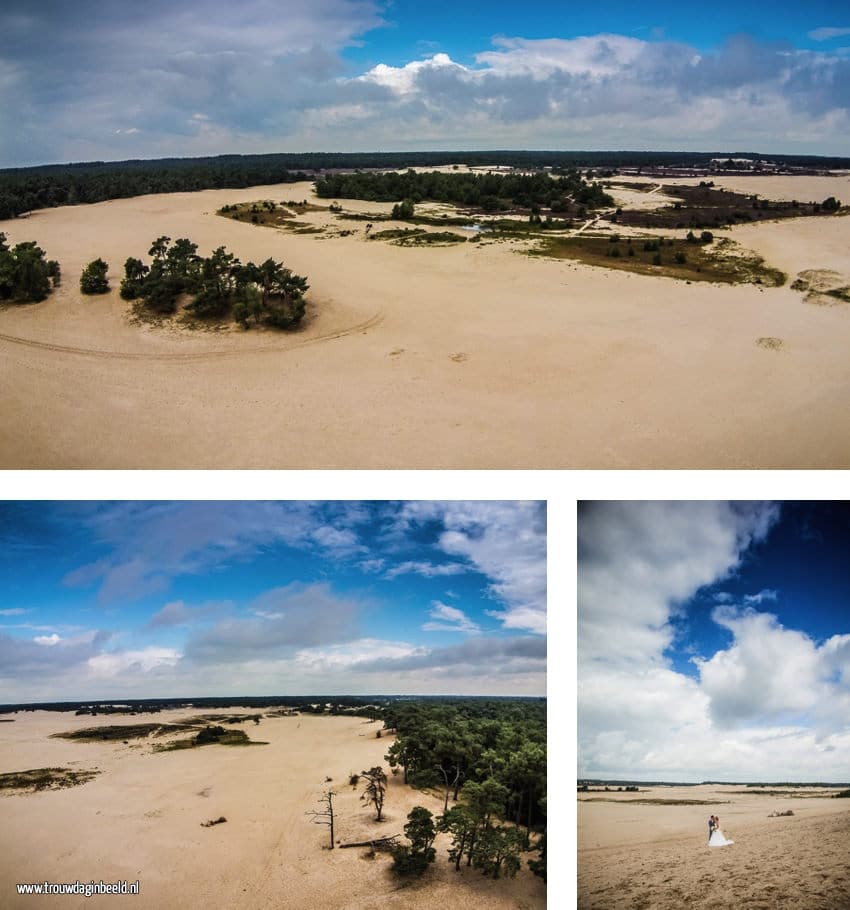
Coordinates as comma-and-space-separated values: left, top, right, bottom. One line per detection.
578, 785, 850, 910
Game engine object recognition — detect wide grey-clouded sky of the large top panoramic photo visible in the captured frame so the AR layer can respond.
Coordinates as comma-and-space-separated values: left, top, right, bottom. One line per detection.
0, 0, 850, 167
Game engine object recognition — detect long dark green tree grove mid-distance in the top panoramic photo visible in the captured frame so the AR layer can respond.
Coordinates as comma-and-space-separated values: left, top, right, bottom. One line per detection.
315, 170, 614, 212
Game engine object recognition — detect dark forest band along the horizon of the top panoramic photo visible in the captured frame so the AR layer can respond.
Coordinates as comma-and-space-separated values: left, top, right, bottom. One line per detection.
0, 150, 850, 220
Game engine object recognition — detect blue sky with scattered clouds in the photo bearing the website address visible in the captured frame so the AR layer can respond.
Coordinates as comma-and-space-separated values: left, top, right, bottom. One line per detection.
0, 501, 546, 703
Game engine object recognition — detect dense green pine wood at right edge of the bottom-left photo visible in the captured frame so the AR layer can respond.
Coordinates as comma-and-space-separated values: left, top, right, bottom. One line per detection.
384, 699, 546, 879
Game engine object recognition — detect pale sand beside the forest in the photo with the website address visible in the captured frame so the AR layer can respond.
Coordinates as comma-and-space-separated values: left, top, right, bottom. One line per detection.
0, 710, 546, 910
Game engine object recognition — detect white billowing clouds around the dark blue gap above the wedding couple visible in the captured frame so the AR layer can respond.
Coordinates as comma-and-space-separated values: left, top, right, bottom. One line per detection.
578, 502, 850, 780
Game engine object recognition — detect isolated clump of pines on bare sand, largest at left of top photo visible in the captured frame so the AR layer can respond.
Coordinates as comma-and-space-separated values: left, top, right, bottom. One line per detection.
121, 236, 309, 329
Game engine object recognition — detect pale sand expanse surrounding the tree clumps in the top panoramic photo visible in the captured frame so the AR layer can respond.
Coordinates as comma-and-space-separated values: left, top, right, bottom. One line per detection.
0, 176, 850, 469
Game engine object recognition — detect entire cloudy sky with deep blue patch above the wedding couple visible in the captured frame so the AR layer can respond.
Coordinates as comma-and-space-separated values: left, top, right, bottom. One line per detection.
578, 502, 850, 781
